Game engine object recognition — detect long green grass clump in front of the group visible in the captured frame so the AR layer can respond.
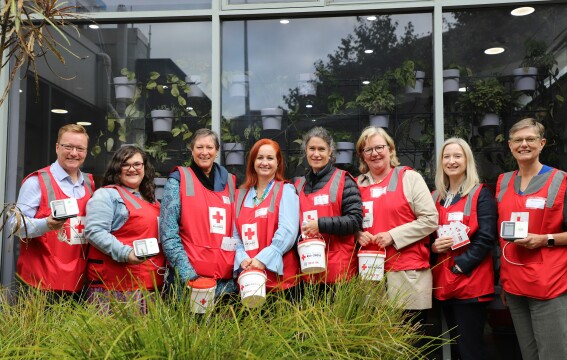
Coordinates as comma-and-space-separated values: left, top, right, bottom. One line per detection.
0, 279, 444, 360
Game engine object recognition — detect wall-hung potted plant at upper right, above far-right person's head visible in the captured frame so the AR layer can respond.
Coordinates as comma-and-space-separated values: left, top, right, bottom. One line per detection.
512, 39, 557, 91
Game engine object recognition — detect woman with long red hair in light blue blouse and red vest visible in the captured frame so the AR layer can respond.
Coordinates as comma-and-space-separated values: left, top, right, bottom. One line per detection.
233, 139, 299, 298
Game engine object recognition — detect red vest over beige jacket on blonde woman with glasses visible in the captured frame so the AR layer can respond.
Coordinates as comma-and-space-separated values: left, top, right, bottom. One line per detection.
359, 166, 429, 271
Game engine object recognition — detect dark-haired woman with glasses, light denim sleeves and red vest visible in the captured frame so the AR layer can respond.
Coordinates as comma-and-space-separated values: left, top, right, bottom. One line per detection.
85, 146, 165, 313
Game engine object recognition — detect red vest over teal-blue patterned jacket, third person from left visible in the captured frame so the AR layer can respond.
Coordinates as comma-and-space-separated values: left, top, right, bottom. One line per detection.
177, 166, 236, 279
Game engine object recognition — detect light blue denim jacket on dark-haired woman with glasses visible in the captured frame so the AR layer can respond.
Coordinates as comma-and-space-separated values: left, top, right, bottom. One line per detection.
85, 186, 142, 263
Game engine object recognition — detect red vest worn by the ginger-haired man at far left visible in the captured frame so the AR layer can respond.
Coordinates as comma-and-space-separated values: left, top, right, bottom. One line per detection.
17, 167, 94, 292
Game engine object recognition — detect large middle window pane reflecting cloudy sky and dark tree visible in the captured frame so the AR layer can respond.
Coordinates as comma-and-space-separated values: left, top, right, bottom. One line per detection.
221, 13, 434, 183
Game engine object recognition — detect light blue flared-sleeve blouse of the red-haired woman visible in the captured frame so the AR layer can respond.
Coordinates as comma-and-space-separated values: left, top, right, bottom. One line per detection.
232, 183, 299, 275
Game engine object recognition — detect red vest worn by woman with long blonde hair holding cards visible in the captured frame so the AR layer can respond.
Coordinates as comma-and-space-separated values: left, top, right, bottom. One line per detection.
431, 185, 494, 301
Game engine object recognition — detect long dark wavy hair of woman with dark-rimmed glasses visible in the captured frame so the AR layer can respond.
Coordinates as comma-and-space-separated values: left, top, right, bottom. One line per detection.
102, 145, 156, 202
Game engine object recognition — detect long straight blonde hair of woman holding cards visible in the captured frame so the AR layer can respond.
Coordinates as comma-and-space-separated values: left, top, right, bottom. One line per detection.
435, 137, 480, 199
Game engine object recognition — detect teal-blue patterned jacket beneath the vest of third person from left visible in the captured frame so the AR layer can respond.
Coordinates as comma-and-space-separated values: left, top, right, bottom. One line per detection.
159, 164, 237, 297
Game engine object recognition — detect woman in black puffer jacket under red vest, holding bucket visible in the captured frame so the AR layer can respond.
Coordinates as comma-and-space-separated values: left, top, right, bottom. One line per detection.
295, 127, 362, 284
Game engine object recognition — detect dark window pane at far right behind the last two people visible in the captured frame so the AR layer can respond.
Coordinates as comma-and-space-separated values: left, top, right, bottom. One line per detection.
443, 5, 567, 184
